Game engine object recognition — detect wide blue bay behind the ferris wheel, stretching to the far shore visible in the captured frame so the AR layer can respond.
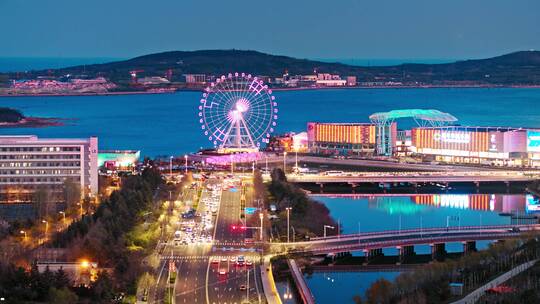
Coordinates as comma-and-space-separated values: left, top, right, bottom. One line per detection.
0, 89, 540, 156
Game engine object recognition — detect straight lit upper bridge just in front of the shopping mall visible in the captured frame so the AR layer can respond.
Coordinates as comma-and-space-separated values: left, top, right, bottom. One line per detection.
287, 170, 540, 184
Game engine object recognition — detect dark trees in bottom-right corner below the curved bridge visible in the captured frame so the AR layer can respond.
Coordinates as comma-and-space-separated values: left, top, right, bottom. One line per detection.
355, 236, 540, 304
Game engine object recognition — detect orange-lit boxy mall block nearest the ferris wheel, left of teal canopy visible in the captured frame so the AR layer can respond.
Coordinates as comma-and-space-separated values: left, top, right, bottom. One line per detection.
307, 122, 377, 155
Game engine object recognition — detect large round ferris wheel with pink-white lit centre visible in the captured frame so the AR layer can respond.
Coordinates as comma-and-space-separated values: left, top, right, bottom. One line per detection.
199, 73, 278, 152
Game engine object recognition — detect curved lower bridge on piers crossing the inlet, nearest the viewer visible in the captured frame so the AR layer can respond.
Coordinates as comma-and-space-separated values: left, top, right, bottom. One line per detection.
271, 224, 540, 258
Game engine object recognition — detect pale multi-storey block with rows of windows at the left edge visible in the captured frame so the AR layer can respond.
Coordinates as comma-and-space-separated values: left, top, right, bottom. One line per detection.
0, 135, 98, 201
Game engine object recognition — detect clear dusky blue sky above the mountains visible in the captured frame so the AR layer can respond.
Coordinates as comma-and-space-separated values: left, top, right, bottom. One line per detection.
0, 0, 540, 59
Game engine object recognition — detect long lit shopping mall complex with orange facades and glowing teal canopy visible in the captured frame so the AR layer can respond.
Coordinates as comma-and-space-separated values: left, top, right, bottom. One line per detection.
307, 109, 540, 167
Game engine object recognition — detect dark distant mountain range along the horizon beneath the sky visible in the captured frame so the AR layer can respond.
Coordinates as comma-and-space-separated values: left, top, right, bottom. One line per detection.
0, 50, 540, 85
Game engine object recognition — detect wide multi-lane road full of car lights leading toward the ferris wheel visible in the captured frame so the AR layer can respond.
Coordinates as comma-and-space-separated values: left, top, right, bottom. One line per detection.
155, 173, 266, 304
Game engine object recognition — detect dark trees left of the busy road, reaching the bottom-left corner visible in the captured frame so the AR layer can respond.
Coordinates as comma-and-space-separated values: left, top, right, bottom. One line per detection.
0, 166, 163, 303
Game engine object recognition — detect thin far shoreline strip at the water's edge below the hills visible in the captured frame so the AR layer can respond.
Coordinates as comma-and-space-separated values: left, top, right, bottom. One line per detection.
0, 84, 540, 97
